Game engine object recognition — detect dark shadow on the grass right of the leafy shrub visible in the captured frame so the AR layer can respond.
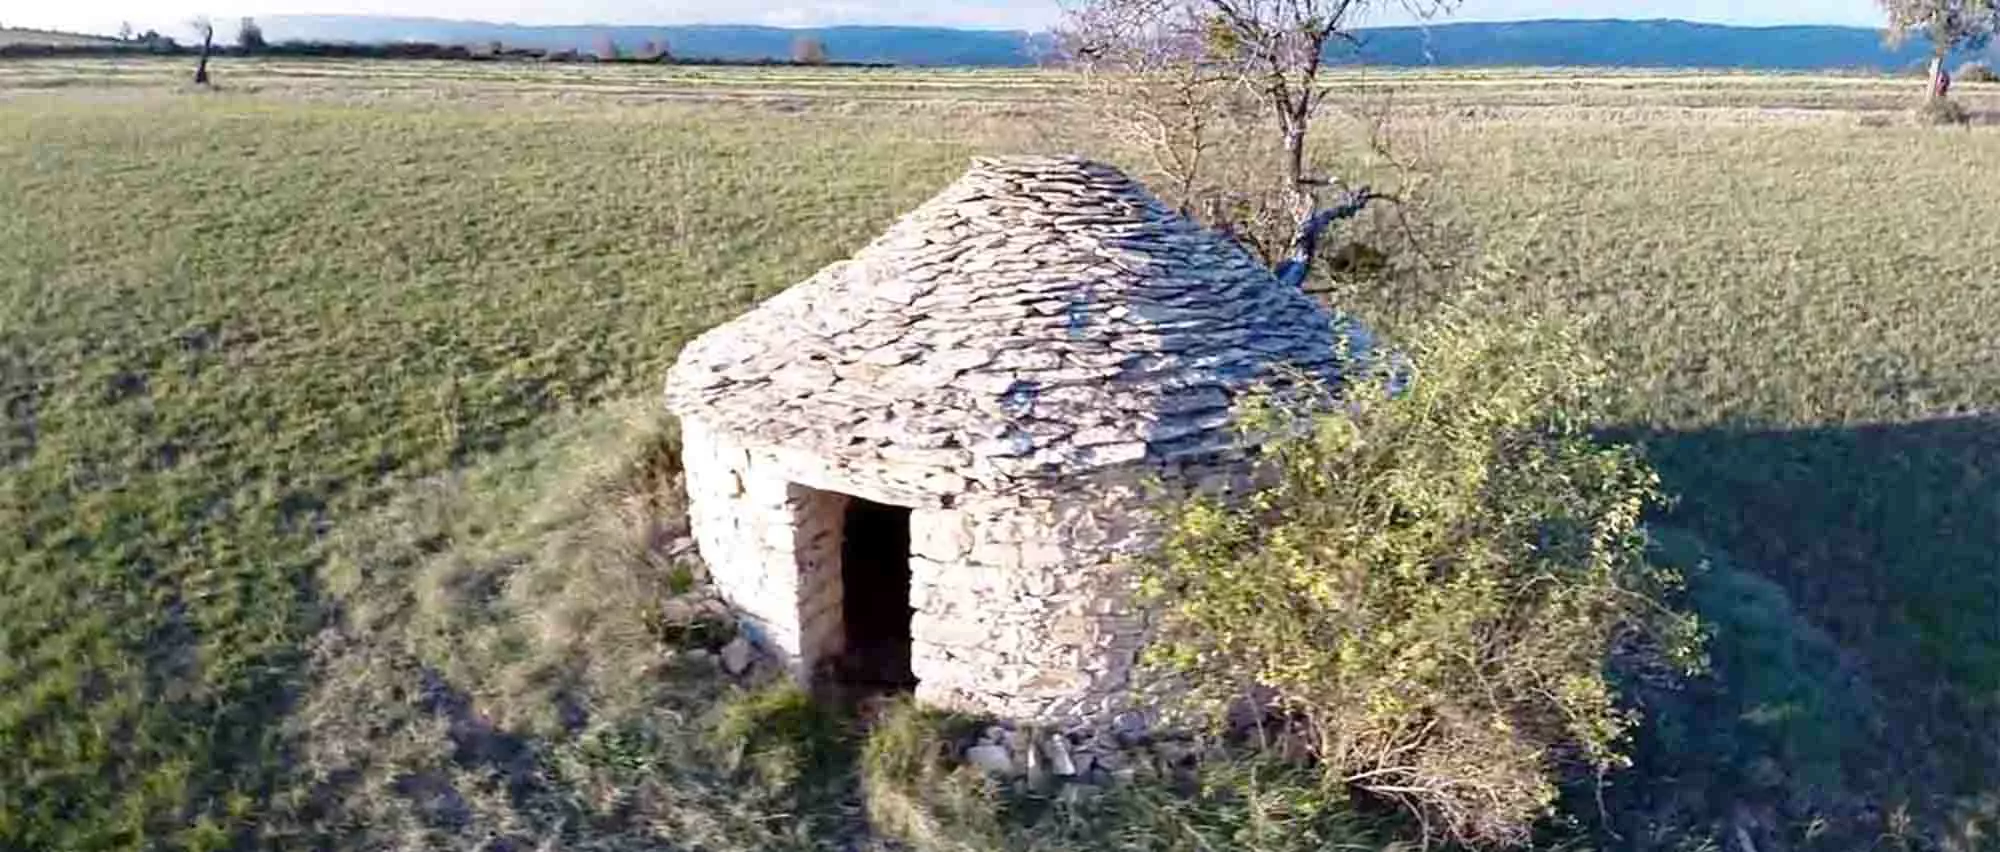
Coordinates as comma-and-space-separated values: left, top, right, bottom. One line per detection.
1610, 416, 2000, 806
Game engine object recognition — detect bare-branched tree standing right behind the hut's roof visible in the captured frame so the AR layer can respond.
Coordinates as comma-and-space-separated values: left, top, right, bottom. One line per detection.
1062, 0, 1456, 282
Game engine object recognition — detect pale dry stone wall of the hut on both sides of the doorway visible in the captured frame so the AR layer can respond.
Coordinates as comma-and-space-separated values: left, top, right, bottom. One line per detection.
682, 422, 1234, 720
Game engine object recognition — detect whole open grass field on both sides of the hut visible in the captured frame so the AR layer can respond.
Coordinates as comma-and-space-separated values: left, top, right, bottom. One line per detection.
0, 60, 2000, 848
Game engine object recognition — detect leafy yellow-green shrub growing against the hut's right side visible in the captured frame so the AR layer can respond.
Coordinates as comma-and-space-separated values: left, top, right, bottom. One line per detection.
1142, 306, 1698, 844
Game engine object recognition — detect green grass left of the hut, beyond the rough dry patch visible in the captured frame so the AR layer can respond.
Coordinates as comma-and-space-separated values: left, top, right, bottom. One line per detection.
0, 96, 992, 848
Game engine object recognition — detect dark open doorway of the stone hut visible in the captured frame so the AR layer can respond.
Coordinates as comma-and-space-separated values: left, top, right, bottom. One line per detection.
840, 498, 916, 692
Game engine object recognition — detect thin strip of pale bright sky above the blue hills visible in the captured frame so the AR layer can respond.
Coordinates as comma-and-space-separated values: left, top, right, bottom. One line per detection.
0, 0, 1882, 41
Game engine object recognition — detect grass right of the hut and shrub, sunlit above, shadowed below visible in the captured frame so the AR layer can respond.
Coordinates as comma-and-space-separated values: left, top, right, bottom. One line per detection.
1336, 113, 2000, 848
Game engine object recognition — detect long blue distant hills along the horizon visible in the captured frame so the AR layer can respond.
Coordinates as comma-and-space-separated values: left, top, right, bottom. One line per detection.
260, 14, 1984, 70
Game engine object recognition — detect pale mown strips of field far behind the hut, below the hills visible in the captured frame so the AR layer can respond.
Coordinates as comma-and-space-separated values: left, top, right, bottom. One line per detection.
11, 58, 2000, 115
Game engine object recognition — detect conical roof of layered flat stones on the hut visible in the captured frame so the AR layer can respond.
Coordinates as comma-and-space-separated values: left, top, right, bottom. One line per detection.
668, 158, 1340, 480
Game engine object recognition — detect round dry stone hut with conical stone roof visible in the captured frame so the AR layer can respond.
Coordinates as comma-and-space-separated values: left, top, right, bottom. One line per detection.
666, 158, 1340, 720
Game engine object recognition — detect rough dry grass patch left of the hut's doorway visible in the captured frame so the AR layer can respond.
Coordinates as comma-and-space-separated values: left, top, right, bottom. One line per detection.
264, 406, 856, 850
